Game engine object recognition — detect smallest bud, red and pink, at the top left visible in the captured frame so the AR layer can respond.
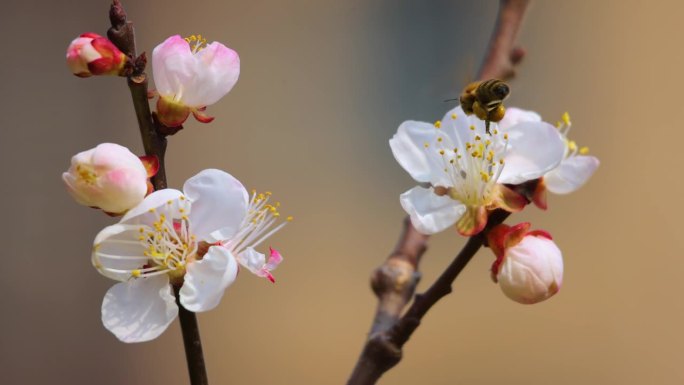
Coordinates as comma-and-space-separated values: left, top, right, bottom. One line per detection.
67, 32, 126, 78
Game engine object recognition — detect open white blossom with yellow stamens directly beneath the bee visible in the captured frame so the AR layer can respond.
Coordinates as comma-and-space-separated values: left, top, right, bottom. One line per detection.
389, 106, 565, 236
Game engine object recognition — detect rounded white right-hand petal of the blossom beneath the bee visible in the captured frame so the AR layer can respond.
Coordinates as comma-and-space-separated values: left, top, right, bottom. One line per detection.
498, 122, 565, 184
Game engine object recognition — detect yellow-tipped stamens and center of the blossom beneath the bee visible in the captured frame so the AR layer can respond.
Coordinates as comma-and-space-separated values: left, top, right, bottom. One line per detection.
425, 114, 508, 206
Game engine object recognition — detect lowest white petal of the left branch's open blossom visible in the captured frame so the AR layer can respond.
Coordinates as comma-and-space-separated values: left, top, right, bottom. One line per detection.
102, 275, 178, 342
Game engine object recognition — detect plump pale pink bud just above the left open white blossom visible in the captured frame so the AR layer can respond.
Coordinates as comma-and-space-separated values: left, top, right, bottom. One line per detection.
62, 143, 148, 214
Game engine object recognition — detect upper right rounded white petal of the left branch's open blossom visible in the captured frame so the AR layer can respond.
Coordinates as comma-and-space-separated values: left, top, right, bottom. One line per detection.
183, 169, 249, 242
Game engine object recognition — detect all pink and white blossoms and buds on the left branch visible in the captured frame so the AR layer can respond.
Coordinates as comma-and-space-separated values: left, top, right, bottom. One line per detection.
62, 33, 292, 342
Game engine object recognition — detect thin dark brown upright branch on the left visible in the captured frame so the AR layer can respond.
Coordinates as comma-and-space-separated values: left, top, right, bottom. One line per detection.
107, 0, 209, 385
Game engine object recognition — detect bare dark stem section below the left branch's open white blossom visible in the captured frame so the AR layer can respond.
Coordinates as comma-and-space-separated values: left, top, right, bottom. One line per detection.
173, 286, 209, 385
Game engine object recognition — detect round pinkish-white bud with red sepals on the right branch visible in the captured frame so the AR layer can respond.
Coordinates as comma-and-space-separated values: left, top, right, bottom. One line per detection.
488, 223, 563, 304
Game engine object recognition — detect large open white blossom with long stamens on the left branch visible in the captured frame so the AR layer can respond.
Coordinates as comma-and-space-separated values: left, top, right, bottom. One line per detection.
92, 169, 291, 342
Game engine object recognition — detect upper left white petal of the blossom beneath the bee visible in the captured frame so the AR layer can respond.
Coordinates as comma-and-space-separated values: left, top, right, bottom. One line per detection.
389, 120, 448, 186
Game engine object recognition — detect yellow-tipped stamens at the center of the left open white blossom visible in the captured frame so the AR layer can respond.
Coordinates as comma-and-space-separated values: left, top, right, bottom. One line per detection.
131, 197, 198, 279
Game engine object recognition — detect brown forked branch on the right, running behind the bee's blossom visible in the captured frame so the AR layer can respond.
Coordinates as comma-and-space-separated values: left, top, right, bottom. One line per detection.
347, 0, 529, 385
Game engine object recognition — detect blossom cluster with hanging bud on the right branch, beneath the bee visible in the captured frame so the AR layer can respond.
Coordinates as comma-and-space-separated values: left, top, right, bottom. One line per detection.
389, 106, 599, 303
